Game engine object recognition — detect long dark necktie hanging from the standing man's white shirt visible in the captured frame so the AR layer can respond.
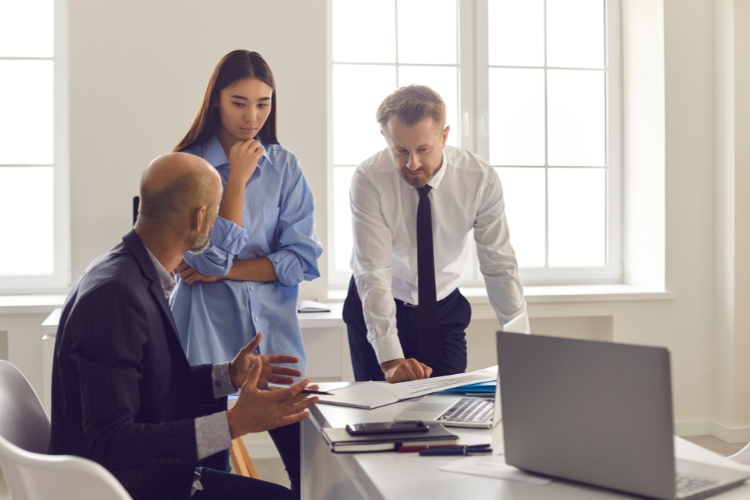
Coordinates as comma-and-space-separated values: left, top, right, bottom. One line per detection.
417, 186, 440, 364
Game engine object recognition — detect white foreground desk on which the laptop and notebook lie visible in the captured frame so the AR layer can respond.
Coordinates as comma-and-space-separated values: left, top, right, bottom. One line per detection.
302, 394, 750, 500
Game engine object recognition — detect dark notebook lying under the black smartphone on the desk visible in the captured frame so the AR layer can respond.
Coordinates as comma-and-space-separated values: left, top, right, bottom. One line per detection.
323, 424, 458, 453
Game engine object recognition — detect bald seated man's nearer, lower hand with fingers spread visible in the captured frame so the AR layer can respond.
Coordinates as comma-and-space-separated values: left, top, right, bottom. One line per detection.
227, 360, 318, 439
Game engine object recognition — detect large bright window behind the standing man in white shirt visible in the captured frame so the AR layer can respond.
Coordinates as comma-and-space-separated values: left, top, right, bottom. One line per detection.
329, 0, 622, 286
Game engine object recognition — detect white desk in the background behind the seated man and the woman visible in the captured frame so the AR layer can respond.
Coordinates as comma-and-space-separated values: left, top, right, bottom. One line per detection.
42, 303, 354, 412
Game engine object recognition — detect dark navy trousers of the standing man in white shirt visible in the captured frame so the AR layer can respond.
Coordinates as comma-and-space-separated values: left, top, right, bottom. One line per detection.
343, 277, 471, 381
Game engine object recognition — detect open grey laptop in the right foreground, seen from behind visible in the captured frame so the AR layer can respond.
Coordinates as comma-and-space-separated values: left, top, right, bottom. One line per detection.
497, 332, 750, 500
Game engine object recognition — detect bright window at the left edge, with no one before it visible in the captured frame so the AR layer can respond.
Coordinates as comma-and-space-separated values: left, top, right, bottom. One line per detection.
0, 0, 69, 293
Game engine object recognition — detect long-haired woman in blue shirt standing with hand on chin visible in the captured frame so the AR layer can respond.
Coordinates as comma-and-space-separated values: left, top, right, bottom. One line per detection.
171, 50, 323, 494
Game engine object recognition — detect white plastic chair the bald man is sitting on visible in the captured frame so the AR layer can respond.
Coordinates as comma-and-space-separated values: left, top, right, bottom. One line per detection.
0, 360, 131, 500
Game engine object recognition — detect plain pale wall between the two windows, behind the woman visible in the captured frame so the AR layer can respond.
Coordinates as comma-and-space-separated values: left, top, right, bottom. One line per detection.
69, 0, 328, 296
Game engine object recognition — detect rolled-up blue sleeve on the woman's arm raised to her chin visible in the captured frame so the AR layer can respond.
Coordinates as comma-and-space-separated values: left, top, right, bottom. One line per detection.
184, 216, 249, 276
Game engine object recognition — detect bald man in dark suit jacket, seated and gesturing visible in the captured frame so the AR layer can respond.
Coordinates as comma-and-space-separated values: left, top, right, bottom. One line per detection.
50, 153, 317, 499
